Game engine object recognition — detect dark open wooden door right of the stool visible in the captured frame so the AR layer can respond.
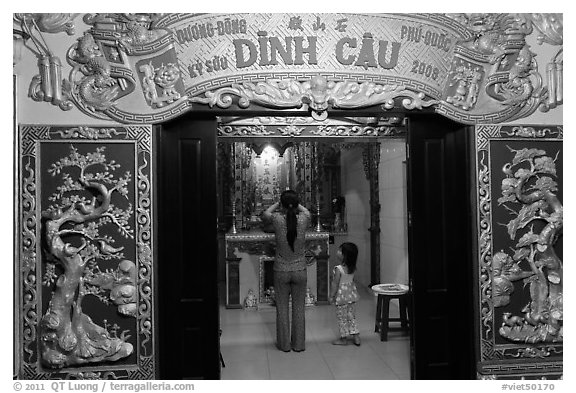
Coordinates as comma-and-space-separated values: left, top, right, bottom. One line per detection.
408, 115, 475, 379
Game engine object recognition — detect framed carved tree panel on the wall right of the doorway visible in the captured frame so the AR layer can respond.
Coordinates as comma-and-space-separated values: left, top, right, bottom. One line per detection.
476, 126, 564, 378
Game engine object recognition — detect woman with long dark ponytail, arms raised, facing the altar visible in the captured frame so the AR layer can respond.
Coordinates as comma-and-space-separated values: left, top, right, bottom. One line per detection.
263, 190, 310, 352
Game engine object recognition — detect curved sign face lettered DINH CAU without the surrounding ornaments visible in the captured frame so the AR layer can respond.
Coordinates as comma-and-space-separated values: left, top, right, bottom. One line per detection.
169, 14, 456, 99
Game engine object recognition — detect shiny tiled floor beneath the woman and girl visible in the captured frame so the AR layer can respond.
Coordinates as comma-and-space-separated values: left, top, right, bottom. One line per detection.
220, 286, 410, 380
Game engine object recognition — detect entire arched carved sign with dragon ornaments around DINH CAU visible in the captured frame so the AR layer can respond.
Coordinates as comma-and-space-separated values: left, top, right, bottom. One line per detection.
44, 13, 561, 124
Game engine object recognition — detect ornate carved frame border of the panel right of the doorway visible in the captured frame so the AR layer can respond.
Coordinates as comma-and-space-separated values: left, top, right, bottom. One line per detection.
475, 125, 563, 379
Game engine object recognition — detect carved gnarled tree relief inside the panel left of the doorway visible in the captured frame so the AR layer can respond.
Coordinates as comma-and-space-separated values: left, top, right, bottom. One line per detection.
39, 145, 136, 368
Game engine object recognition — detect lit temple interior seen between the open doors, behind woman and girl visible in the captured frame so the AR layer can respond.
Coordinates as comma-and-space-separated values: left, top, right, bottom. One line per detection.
217, 116, 411, 380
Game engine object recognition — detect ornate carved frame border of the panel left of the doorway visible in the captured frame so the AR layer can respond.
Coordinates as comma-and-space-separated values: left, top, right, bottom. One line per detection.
15, 125, 157, 380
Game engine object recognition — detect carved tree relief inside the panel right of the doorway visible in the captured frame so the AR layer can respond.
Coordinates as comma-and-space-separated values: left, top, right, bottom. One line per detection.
492, 148, 563, 343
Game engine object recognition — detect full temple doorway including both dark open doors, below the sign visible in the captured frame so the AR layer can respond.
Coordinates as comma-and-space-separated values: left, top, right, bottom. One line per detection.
156, 112, 476, 379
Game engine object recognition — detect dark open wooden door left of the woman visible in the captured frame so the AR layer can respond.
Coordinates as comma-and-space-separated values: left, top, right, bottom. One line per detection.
156, 117, 220, 379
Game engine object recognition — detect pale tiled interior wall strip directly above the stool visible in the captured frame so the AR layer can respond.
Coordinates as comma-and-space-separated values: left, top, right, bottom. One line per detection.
378, 139, 408, 285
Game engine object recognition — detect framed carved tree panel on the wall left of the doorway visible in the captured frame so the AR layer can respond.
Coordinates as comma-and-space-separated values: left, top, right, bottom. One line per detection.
16, 126, 156, 379
